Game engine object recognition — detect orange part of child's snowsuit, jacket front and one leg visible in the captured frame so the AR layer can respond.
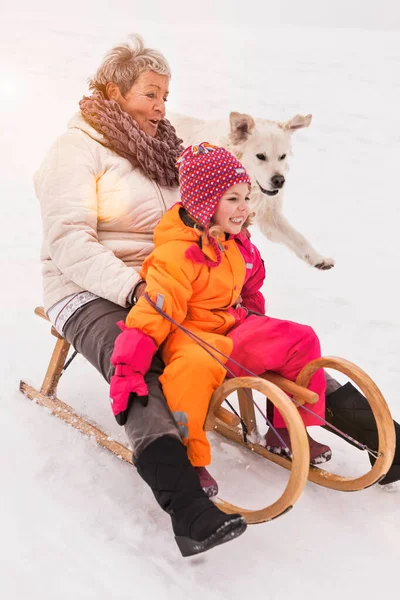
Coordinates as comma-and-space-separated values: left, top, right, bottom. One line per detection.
126, 204, 246, 466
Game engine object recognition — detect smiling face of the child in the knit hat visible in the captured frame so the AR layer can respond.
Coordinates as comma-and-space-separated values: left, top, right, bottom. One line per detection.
212, 183, 250, 235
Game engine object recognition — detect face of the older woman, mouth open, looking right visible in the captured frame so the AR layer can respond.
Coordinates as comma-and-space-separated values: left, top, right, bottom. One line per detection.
111, 71, 169, 137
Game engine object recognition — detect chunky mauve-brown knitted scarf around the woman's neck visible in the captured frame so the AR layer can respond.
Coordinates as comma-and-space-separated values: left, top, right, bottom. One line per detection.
79, 91, 184, 186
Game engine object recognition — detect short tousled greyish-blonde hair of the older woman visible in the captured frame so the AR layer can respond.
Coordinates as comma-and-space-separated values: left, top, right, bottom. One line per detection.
89, 33, 171, 96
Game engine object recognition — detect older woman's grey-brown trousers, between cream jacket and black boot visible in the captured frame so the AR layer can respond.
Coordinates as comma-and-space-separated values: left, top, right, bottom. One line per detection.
63, 298, 181, 458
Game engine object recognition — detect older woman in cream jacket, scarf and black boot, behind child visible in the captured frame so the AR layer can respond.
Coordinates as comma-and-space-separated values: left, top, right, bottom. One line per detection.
35, 36, 246, 556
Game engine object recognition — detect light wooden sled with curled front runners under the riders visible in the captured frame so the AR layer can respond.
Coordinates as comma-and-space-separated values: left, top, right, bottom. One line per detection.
20, 307, 395, 523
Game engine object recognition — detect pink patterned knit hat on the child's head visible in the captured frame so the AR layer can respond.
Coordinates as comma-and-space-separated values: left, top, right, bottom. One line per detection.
176, 142, 251, 227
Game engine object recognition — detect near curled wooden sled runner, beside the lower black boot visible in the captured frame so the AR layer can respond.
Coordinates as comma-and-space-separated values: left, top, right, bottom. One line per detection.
204, 377, 310, 523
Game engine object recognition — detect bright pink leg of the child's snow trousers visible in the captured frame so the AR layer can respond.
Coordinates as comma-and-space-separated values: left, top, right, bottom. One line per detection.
226, 315, 326, 427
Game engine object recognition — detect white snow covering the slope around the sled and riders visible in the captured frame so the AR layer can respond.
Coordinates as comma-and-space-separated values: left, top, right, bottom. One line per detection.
0, 0, 400, 600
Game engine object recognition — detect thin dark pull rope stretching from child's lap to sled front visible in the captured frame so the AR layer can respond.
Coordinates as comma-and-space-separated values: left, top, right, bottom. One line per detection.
144, 293, 379, 458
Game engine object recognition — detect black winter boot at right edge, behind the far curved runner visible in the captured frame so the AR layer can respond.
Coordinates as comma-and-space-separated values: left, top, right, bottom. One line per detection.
325, 382, 400, 485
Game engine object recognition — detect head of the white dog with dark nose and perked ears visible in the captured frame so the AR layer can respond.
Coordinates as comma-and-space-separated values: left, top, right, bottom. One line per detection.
229, 112, 312, 197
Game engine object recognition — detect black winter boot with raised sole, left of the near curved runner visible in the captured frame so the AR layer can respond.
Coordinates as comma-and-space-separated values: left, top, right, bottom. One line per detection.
136, 435, 247, 556
